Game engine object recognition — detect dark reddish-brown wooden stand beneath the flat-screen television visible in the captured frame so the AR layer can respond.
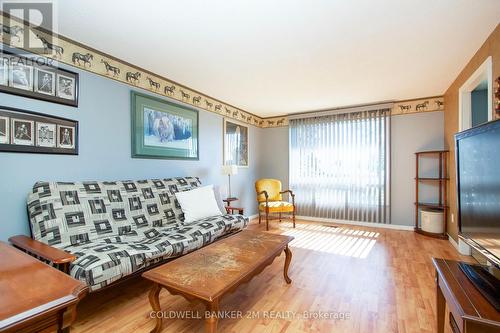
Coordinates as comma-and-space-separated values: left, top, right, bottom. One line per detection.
432, 258, 500, 333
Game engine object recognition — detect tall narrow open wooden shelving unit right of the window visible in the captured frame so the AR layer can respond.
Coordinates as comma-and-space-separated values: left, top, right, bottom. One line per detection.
415, 150, 450, 239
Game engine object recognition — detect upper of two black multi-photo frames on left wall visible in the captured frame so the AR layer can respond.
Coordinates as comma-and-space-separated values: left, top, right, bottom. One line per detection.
0, 51, 79, 107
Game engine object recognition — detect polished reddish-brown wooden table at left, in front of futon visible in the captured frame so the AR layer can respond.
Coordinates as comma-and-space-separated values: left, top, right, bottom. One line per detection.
0, 242, 88, 332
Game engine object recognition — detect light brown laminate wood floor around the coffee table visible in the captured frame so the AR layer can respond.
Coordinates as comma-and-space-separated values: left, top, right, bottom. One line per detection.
72, 220, 471, 333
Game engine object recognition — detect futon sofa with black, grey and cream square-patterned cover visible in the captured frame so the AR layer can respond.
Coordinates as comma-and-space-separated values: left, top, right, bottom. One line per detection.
11, 177, 248, 291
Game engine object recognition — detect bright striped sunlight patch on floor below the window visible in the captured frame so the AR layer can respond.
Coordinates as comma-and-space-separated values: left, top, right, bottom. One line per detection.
282, 223, 379, 259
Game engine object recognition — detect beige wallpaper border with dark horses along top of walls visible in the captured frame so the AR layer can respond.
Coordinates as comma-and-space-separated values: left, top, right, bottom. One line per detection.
0, 11, 444, 128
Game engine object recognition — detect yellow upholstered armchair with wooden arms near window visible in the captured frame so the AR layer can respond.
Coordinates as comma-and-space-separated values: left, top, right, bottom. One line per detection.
255, 179, 295, 230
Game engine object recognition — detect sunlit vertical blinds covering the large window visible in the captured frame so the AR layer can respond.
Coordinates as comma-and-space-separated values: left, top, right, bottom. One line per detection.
290, 109, 390, 223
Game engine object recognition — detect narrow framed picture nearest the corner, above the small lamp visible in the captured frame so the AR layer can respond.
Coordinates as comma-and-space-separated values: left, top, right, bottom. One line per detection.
222, 118, 249, 168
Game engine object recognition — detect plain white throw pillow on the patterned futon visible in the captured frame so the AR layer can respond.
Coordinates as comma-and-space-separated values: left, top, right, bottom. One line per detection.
175, 185, 222, 223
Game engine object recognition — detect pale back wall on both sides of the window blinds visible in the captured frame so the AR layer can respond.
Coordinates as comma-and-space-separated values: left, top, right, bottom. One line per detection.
259, 112, 444, 225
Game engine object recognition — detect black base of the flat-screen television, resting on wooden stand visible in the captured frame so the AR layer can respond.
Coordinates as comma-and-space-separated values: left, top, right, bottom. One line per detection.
458, 262, 500, 311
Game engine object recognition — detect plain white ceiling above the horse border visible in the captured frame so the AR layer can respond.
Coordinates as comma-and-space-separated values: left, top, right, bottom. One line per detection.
41, 0, 500, 117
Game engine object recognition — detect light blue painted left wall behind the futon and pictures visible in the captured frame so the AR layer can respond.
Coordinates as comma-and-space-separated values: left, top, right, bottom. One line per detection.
0, 61, 264, 240
